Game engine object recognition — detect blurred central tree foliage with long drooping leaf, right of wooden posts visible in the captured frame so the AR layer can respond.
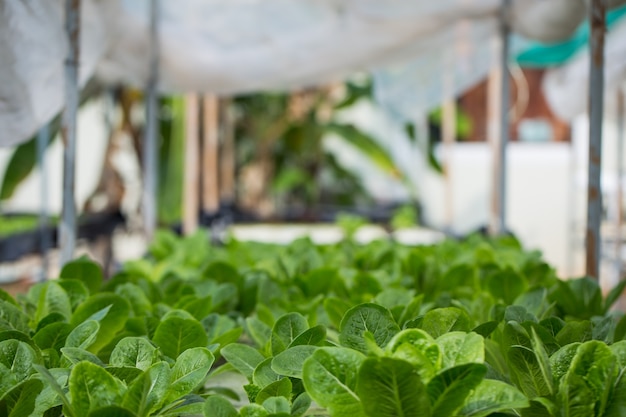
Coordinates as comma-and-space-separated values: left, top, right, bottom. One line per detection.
234, 80, 410, 218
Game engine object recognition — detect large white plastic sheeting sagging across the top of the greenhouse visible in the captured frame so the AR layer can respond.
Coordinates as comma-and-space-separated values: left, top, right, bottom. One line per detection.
0, 0, 625, 146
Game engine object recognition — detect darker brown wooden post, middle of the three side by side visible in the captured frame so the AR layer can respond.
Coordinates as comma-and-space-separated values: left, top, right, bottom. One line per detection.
202, 95, 220, 215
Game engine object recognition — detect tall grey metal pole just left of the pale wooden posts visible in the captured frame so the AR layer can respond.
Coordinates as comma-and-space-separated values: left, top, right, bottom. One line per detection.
142, 0, 159, 240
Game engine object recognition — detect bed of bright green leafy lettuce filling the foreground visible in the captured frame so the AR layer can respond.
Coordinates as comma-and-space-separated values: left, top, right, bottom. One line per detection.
0, 229, 626, 417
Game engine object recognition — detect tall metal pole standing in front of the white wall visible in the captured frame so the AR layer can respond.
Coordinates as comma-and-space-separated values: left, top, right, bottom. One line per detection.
490, 0, 511, 236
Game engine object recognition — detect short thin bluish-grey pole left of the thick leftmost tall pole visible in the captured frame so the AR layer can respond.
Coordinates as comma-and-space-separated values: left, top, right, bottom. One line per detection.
37, 124, 52, 281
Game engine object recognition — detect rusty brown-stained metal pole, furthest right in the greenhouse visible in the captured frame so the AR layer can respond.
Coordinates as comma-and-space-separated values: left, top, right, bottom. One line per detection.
585, 0, 606, 279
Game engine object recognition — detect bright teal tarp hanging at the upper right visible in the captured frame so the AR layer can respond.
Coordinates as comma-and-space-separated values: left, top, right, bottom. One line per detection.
515, 6, 626, 68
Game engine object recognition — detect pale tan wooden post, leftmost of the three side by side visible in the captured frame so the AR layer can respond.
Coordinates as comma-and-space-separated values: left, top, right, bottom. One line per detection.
183, 94, 200, 235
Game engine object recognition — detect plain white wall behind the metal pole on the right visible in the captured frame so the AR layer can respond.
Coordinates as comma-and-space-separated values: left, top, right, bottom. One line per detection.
421, 142, 572, 275
